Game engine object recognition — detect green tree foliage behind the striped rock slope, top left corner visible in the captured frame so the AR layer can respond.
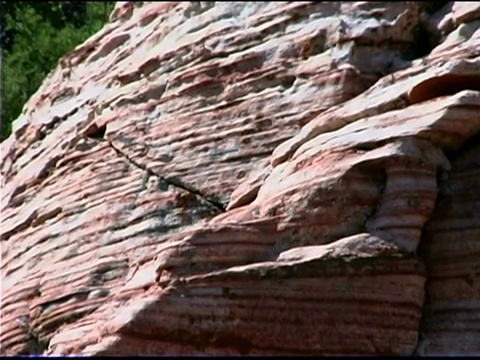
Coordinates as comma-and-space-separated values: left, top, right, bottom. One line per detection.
0, 1, 115, 141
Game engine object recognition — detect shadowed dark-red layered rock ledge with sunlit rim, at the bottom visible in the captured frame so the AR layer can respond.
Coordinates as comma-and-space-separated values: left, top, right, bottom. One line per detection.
58, 240, 425, 355
